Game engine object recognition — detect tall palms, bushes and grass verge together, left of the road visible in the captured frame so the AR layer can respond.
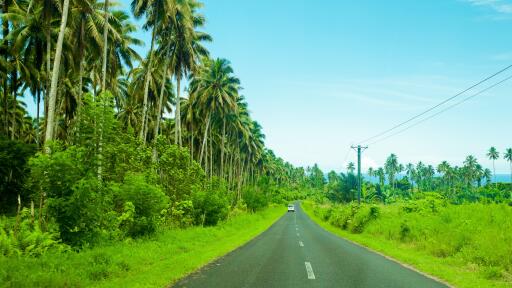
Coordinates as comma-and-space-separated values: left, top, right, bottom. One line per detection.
0, 0, 312, 287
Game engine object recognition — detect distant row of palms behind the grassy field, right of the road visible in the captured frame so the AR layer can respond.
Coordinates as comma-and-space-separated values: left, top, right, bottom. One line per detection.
315, 152, 512, 204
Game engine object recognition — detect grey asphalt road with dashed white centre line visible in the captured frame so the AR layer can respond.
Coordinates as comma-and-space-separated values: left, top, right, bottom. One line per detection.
174, 204, 446, 288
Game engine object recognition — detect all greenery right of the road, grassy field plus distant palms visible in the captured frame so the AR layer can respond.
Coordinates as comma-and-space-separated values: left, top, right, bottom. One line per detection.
303, 152, 512, 287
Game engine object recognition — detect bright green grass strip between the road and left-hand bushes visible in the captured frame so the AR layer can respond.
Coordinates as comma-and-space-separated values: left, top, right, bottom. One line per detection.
0, 206, 285, 287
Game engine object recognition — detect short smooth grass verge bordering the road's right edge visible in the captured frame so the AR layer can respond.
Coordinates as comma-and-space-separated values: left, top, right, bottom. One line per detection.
301, 201, 512, 288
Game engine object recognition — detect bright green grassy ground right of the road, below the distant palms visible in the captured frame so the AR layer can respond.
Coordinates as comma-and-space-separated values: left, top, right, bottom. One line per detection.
302, 200, 512, 287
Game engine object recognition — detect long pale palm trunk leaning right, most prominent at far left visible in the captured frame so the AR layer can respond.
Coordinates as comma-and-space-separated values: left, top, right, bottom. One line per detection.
45, 0, 69, 145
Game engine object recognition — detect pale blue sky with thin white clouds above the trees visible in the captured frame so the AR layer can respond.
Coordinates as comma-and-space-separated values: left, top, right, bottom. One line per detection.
29, 0, 512, 173
